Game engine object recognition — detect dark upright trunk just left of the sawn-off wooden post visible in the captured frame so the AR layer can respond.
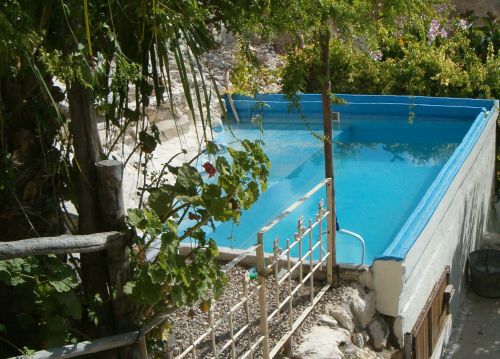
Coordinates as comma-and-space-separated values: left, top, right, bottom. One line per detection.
68, 82, 116, 357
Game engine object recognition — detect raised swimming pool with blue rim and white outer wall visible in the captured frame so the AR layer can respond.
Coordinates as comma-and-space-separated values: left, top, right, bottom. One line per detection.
213, 94, 499, 347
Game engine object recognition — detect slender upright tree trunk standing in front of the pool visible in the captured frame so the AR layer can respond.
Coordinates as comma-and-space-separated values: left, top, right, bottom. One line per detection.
320, 24, 337, 280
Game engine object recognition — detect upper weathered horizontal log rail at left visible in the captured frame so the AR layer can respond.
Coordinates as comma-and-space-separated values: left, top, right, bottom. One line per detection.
0, 231, 124, 260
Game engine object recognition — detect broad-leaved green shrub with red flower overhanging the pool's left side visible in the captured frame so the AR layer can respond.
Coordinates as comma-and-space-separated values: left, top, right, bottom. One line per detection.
125, 140, 269, 320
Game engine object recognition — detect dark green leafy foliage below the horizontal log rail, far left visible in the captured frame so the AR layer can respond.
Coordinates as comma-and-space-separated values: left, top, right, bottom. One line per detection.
0, 255, 82, 347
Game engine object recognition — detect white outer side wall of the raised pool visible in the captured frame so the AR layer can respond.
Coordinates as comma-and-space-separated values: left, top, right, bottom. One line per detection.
373, 110, 497, 344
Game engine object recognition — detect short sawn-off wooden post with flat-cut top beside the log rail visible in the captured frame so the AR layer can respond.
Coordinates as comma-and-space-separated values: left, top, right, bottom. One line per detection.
96, 160, 140, 358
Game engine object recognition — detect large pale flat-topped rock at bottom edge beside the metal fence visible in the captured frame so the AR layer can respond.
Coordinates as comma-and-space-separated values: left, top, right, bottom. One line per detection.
295, 326, 352, 359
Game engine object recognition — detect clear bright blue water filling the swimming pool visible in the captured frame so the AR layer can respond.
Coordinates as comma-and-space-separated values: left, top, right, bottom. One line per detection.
204, 116, 471, 264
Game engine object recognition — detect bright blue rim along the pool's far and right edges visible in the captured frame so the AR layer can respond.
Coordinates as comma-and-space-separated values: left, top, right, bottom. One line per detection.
226, 94, 498, 261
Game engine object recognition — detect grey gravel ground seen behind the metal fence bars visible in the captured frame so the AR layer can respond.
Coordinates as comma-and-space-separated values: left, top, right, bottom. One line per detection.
162, 266, 342, 358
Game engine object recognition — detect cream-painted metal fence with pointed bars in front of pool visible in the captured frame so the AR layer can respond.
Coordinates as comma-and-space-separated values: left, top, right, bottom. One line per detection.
170, 179, 335, 359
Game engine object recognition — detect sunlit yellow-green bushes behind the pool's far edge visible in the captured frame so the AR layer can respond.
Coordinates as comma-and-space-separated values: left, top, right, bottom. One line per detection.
282, 9, 500, 97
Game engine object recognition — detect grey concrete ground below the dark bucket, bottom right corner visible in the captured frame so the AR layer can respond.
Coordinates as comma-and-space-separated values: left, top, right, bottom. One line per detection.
443, 289, 500, 359
